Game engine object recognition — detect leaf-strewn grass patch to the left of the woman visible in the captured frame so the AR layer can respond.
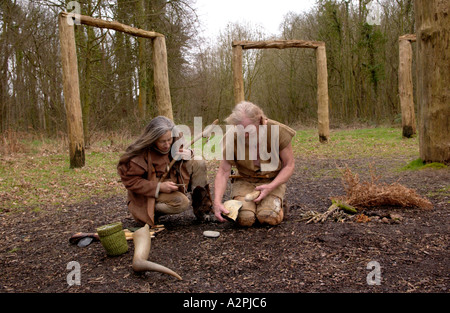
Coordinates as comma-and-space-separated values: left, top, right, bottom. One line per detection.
0, 143, 125, 212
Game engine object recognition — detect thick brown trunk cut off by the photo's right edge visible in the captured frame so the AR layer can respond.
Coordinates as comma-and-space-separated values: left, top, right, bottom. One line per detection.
415, 0, 450, 163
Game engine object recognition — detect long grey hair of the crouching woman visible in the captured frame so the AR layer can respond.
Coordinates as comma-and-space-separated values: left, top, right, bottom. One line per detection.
119, 116, 175, 164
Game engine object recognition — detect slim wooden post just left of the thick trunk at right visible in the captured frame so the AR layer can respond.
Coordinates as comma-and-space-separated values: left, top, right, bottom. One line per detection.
398, 39, 416, 138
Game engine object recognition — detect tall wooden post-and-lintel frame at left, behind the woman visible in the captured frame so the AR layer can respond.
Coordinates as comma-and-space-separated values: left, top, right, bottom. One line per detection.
59, 12, 173, 168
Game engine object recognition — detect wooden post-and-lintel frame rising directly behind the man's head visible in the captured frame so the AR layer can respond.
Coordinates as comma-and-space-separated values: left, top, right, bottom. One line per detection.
232, 40, 330, 142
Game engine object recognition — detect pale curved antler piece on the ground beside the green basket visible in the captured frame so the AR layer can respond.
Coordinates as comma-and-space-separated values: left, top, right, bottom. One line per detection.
132, 224, 183, 280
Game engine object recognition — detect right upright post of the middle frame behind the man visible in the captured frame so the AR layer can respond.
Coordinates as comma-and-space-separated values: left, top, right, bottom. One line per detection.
316, 45, 330, 143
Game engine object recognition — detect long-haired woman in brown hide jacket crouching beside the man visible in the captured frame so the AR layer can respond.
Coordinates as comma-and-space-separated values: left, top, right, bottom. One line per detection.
117, 116, 212, 226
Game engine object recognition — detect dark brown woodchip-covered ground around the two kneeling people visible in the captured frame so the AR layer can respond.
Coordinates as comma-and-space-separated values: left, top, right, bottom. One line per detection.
0, 159, 450, 293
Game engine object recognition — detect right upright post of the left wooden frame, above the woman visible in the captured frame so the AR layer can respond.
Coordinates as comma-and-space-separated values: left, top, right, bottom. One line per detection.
153, 37, 173, 120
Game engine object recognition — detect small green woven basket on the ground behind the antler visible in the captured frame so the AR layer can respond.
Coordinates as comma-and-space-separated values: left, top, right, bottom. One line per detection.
97, 222, 128, 256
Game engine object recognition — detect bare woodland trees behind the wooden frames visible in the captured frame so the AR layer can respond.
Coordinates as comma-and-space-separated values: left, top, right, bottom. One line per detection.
0, 0, 415, 145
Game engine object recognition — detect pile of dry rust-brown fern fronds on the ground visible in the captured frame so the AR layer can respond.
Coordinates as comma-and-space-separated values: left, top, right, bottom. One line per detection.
341, 166, 433, 209
